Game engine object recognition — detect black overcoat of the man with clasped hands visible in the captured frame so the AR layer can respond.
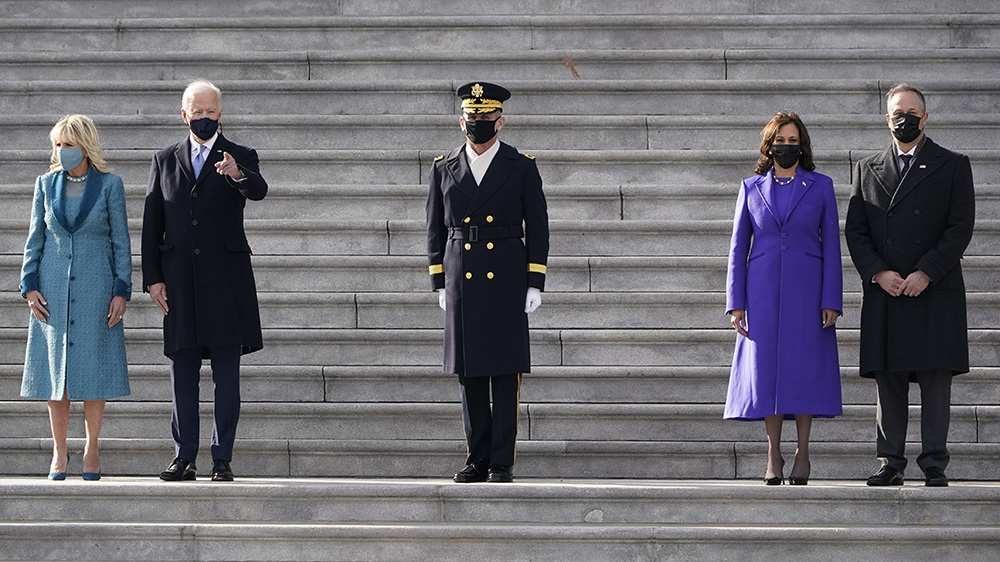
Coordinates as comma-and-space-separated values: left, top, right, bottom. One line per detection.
845, 138, 976, 377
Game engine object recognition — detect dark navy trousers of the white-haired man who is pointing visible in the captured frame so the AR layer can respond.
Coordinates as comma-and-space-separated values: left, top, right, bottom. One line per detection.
170, 345, 240, 462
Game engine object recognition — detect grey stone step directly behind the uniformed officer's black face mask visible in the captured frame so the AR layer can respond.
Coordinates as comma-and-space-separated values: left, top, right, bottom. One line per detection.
7, 111, 1000, 152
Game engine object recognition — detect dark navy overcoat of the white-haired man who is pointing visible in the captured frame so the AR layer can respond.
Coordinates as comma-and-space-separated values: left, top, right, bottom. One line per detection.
142, 134, 267, 355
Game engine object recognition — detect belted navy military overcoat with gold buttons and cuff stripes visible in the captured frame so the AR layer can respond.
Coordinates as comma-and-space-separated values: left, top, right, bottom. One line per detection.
427, 141, 549, 377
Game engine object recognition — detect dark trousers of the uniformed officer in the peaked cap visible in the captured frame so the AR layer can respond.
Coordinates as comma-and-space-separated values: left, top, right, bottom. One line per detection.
458, 374, 521, 466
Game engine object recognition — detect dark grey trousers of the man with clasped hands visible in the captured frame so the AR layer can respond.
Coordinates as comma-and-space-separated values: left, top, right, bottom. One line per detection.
875, 370, 951, 470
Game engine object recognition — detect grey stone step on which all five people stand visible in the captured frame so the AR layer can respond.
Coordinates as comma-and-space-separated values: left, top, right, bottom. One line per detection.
0, 477, 1000, 528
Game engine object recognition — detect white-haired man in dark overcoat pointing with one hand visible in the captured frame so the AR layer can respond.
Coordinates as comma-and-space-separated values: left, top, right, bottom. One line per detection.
142, 80, 267, 481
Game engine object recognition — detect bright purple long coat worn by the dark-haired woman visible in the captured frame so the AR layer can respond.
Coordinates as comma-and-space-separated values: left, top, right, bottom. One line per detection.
725, 167, 843, 420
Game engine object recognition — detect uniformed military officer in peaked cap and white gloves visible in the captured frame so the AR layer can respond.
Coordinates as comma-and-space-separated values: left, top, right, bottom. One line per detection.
427, 82, 549, 482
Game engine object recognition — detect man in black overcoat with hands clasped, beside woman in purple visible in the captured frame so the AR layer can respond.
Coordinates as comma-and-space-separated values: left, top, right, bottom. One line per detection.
845, 84, 976, 486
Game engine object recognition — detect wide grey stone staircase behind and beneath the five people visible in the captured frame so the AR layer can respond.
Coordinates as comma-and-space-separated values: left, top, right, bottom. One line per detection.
0, 0, 1000, 560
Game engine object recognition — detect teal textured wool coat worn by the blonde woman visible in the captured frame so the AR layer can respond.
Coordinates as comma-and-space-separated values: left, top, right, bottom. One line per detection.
21, 168, 132, 400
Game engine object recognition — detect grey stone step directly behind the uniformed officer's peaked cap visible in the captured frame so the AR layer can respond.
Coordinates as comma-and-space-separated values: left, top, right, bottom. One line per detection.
0, 79, 1000, 117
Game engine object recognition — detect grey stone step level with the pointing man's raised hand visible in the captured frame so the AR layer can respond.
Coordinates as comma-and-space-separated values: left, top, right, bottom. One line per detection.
7, 147, 1000, 190
